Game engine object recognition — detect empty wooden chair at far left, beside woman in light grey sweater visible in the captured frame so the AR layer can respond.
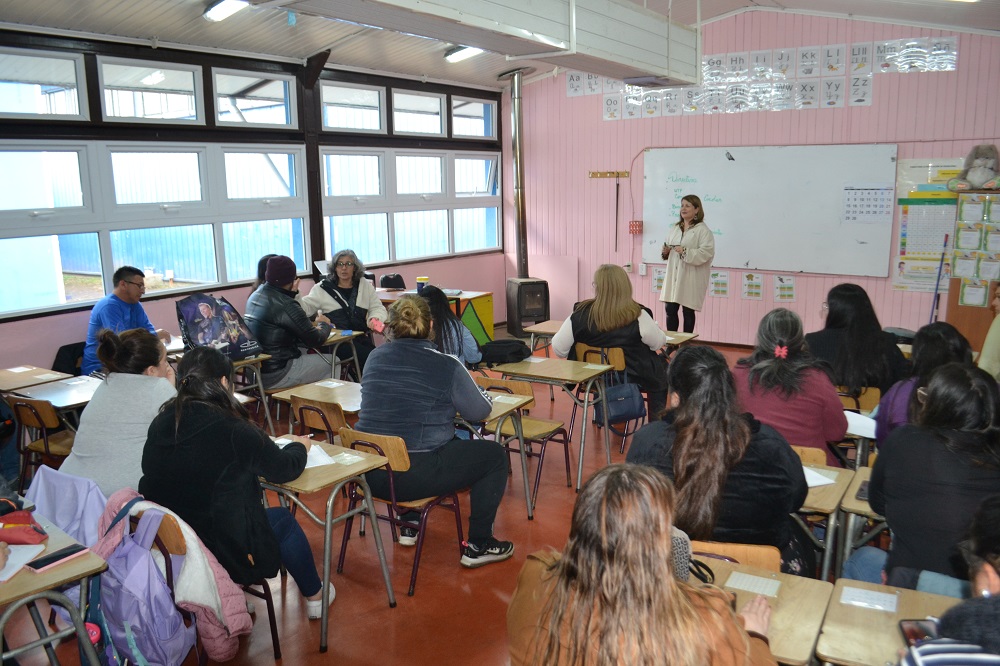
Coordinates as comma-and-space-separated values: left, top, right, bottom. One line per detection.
8, 396, 76, 495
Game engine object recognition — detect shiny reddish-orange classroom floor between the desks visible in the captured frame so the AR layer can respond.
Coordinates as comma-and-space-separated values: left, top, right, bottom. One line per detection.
8, 338, 737, 666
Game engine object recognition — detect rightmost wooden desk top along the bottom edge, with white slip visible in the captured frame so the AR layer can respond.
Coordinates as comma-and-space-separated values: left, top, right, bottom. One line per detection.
816, 578, 962, 666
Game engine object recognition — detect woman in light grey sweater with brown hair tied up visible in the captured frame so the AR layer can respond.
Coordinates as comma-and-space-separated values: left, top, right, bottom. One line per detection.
60, 328, 177, 497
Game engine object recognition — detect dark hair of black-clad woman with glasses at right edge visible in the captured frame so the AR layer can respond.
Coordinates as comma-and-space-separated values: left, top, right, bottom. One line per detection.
915, 363, 1000, 467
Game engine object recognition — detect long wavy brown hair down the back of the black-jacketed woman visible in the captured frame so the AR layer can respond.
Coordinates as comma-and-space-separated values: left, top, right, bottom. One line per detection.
667, 346, 750, 539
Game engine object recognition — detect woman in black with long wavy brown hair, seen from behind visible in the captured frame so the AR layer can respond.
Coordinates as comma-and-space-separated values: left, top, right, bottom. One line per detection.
626, 346, 815, 575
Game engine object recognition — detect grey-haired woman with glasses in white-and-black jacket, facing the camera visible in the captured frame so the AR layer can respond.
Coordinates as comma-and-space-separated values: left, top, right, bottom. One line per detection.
300, 250, 388, 373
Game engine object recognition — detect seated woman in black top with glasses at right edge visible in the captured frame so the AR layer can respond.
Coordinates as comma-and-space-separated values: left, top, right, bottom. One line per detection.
868, 363, 1000, 589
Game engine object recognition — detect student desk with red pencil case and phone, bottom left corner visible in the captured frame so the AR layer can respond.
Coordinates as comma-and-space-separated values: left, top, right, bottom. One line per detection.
0, 513, 108, 664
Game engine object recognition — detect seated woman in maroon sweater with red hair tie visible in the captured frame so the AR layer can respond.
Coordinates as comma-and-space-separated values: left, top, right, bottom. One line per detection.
733, 308, 847, 466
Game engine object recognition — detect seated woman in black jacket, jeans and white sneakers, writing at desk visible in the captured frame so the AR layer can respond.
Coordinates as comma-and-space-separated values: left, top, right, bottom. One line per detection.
139, 347, 335, 619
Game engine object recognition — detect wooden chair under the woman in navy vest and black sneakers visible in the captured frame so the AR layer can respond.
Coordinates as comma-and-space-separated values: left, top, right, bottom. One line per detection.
337, 428, 465, 597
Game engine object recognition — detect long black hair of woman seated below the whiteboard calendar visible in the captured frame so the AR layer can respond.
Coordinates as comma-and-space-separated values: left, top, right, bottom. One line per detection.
824, 283, 892, 395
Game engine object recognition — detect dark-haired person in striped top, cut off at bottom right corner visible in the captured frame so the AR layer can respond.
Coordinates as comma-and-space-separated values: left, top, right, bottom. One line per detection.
900, 495, 1000, 666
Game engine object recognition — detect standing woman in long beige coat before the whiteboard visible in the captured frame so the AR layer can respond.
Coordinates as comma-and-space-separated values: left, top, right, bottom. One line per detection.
660, 194, 715, 333
